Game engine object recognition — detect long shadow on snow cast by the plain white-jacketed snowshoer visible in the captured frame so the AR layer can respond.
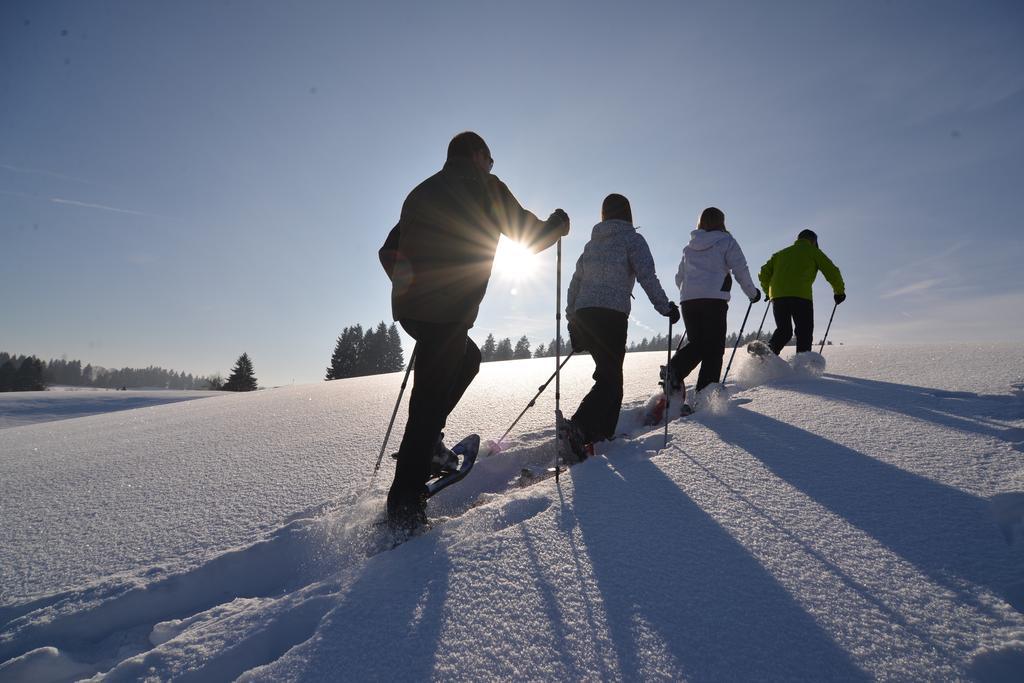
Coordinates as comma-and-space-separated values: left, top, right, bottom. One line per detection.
705, 407, 1024, 611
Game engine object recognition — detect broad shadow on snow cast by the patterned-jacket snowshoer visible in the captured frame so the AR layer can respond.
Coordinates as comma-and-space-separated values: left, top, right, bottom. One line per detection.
572, 448, 869, 680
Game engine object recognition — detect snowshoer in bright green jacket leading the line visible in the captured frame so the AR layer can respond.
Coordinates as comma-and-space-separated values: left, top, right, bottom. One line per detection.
758, 230, 846, 355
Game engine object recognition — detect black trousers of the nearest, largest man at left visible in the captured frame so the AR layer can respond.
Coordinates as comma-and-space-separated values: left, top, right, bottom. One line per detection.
388, 319, 480, 503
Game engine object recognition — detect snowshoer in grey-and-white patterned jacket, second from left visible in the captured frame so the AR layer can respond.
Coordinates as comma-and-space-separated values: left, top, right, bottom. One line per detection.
559, 195, 679, 460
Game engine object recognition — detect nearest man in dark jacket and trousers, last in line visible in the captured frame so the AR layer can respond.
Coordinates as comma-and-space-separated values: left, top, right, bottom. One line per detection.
380, 132, 569, 530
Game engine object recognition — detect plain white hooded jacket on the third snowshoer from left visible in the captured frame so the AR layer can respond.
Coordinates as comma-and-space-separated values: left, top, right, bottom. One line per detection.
676, 230, 758, 301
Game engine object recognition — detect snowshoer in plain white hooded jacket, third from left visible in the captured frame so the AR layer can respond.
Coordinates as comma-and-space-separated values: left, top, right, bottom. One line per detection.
670, 207, 761, 391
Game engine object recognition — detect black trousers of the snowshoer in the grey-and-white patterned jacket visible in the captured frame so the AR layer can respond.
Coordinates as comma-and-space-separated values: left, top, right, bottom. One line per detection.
572, 308, 628, 443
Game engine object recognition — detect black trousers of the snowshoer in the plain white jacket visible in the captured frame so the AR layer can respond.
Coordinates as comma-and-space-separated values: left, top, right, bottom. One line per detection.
671, 299, 729, 391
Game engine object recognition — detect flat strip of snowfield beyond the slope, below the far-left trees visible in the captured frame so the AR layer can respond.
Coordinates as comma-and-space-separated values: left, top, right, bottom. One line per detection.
0, 387, 222, 429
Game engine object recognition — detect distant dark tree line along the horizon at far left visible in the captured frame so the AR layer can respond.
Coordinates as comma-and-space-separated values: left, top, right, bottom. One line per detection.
0, 351, 216, 391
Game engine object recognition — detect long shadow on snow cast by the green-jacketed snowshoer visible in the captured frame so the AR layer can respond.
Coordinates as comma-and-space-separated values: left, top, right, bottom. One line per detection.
794, 374, 1024, 451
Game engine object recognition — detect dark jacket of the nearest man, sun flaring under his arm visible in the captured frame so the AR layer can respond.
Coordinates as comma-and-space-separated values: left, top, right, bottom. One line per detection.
380, 160, 562, 327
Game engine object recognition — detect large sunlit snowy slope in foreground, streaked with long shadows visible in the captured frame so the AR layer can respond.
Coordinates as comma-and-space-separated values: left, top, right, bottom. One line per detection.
0, 345, 1024, 681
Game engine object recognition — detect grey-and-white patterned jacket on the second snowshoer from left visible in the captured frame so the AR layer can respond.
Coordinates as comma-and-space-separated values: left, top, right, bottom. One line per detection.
565, 219, 669, 315
